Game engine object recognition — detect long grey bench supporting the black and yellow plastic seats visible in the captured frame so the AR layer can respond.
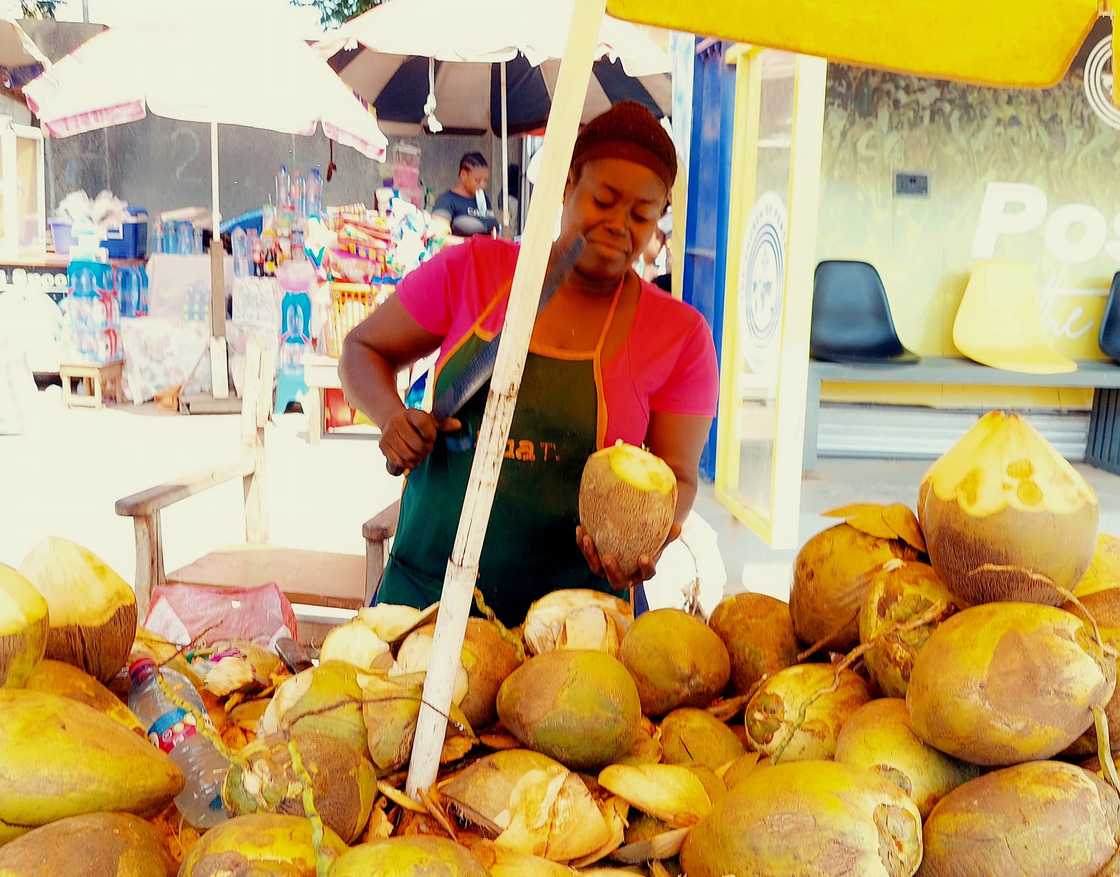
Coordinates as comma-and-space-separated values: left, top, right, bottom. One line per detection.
803, 356, 1120, 473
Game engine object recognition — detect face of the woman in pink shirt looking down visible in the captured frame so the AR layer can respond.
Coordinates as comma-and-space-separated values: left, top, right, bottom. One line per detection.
561, 158, 669, 280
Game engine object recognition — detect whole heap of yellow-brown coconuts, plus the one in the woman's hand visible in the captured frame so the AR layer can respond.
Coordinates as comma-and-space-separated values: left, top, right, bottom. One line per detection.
0, 421, 1120, 877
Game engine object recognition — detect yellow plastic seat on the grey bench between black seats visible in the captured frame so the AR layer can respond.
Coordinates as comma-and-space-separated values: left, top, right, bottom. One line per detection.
953, 260, 1077, 374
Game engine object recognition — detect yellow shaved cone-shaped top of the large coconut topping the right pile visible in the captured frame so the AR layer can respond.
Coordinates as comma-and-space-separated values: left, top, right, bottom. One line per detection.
923, 411, 1098, 517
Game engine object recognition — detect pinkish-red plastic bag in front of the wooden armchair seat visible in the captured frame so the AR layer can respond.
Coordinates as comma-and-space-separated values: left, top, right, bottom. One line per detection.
144, 584, 299, 649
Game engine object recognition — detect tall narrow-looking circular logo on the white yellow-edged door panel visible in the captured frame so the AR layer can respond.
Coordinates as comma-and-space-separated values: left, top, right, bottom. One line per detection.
739, 192, 785, 374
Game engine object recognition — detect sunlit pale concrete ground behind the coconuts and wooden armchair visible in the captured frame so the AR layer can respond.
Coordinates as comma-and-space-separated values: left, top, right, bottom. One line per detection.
0, 388, 1120, 609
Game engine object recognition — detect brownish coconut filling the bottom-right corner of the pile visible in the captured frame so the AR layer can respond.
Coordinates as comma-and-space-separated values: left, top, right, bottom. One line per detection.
920, 762, 1120, 877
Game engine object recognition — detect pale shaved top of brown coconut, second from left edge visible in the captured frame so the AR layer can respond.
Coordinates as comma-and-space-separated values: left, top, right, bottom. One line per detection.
20, 537, 136, 627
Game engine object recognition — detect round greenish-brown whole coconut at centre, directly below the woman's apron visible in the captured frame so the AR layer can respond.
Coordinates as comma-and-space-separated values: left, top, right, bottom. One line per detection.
497, 650, 642, 769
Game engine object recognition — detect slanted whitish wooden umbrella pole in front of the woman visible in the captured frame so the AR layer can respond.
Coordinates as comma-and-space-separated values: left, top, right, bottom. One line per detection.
407, 0, 606, 797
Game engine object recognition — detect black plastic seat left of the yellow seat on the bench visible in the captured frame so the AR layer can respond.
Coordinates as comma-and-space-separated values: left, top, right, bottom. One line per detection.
809, 260, 920, 365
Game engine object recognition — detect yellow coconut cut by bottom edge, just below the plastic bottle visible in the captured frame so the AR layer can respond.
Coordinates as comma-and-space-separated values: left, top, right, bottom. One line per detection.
179, 814, 346, 877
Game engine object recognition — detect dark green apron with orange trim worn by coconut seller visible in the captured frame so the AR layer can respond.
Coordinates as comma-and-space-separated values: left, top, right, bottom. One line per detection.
375, 286, 628, 626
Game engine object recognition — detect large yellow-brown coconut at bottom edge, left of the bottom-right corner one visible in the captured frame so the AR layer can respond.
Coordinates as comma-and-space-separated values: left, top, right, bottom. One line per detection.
681, 762, 922, 877
